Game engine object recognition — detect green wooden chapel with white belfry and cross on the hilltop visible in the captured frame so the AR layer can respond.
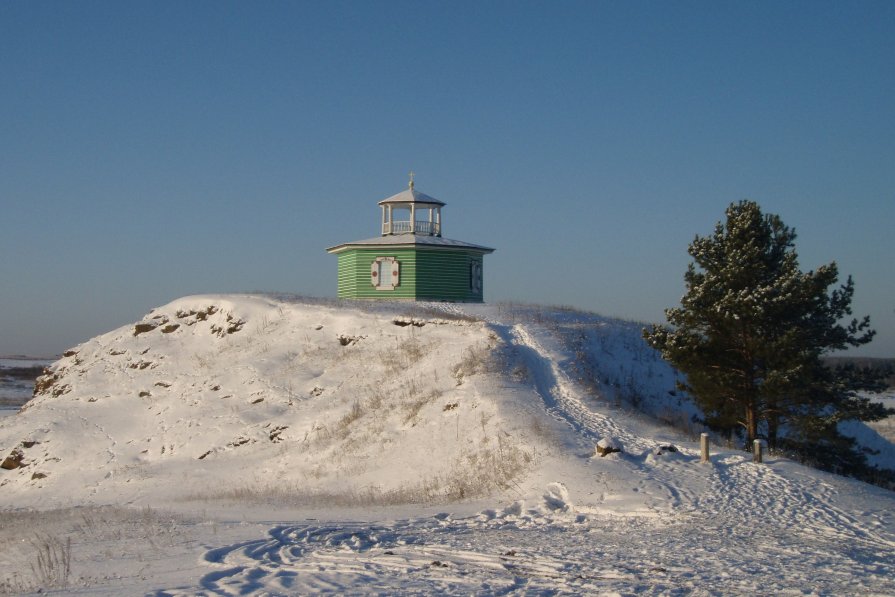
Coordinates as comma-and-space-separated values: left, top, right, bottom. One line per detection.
327, 174, 494, 303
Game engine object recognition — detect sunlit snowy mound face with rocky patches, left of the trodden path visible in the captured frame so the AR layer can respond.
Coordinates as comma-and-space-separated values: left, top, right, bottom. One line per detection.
0, 295, 536, 504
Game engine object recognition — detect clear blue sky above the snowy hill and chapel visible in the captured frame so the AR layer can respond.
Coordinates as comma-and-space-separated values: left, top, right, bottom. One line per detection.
0, 0, 895, 356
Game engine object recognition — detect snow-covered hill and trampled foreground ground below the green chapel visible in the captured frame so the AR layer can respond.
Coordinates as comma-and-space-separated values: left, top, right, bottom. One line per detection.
0, 295, 895, 595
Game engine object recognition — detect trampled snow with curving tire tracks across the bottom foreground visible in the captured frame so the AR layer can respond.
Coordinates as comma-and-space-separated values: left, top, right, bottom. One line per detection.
161, 508, 895, 596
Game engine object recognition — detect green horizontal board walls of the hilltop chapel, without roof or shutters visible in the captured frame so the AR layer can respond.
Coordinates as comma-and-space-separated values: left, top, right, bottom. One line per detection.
338, 243, 483, 302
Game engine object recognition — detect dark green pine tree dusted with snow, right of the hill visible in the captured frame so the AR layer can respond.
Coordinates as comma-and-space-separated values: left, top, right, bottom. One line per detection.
644, 201, 895, 466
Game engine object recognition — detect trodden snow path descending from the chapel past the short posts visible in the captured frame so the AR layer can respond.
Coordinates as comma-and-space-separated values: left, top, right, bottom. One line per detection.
495, 324, 895, 550
